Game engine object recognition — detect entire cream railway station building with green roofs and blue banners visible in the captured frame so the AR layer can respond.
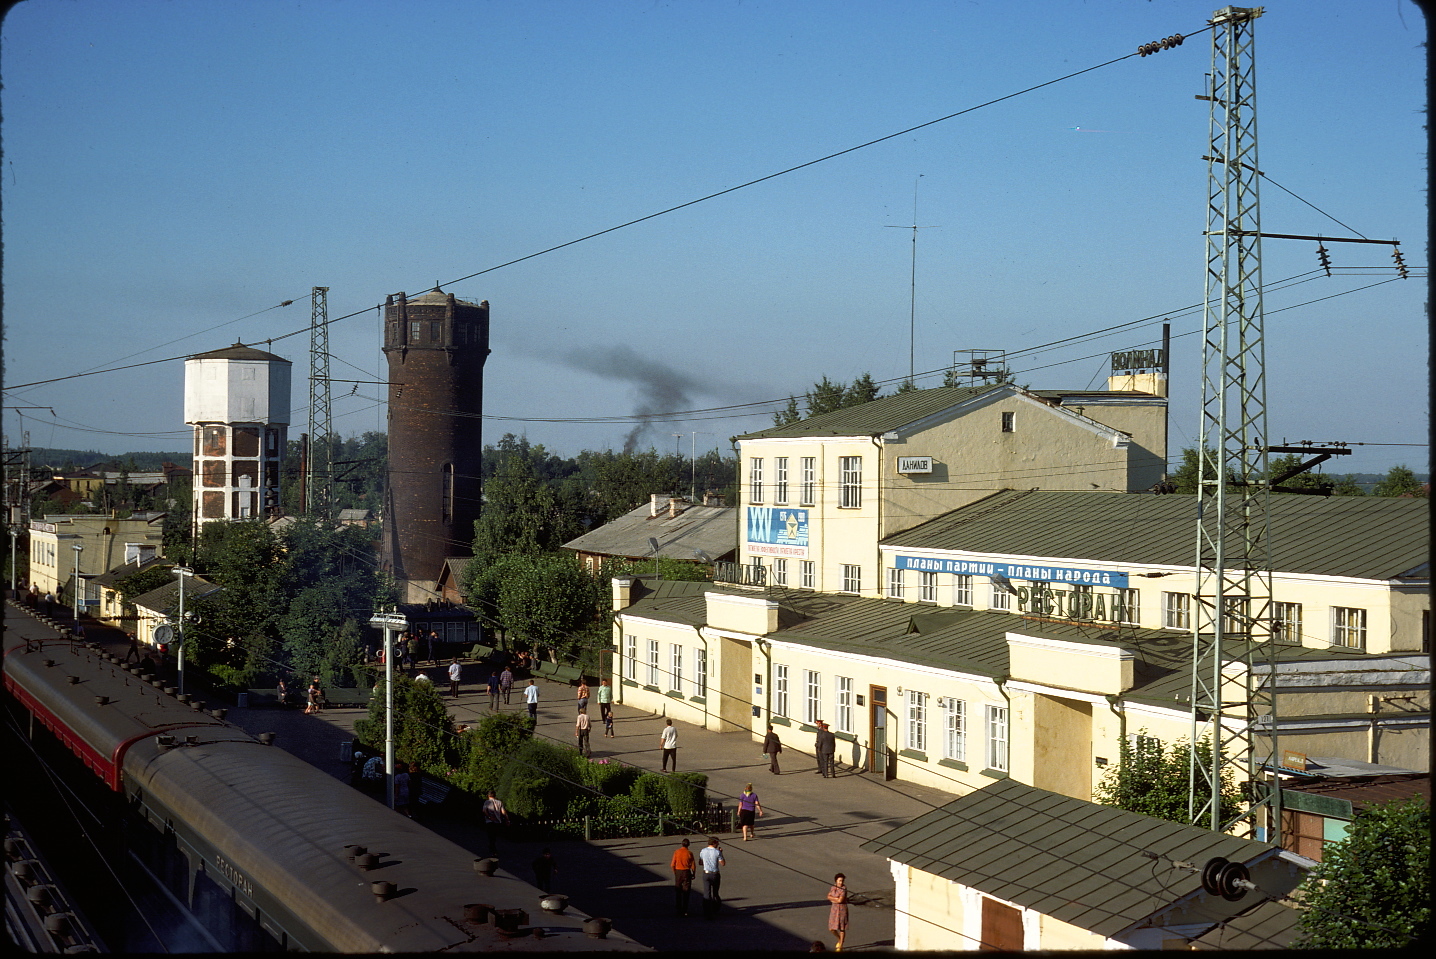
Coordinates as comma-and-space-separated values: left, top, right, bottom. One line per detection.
613, 386, 1430, 800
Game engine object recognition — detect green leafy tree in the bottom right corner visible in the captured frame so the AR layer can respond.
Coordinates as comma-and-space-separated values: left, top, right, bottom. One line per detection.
1297, 798, 1432, 950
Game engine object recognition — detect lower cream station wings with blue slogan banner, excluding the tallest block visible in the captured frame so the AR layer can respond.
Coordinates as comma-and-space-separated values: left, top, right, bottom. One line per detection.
615, 491, 1430, 798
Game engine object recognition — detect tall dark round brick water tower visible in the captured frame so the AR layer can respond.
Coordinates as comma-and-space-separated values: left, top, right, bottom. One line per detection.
383, 290, 488, 603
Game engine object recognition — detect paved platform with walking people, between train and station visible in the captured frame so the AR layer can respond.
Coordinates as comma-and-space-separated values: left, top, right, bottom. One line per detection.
6, 604, 955, 950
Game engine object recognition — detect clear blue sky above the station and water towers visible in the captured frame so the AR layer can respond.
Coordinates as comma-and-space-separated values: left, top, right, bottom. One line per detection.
0, 0, 1429, 472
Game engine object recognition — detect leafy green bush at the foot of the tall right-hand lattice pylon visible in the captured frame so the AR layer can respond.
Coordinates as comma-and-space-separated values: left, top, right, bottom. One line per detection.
1093, 729, 1242, 823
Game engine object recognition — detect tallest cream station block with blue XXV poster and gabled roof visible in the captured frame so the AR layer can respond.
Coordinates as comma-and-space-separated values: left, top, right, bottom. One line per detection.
737, 385, 1166, 596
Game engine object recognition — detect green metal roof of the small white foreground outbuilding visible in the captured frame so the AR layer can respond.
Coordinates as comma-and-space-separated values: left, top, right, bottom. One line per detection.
860, 780, 1277, 936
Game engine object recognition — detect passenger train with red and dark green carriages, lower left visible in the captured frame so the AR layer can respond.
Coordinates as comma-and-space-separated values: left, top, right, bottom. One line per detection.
4, 639, 642, 953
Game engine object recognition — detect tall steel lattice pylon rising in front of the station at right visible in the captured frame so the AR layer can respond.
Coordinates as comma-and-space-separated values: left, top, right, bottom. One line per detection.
1190, 7, 1281, 841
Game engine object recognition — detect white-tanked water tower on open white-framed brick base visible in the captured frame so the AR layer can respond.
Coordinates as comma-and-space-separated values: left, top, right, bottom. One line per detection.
184, 343, 293, 528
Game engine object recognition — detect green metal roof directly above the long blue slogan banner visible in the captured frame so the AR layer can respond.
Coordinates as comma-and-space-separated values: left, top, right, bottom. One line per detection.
883, 490, 1430, 580
